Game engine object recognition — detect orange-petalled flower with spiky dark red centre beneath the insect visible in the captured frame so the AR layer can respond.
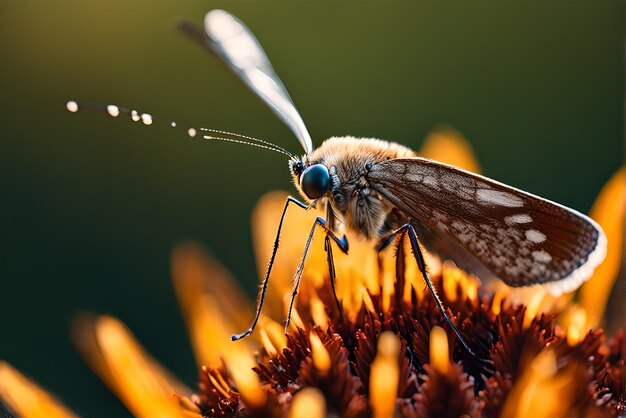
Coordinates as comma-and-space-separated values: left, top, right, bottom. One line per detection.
0, 128, 626, 418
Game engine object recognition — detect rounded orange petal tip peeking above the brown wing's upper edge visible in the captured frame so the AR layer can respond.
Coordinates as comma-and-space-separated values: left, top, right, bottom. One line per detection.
420, 125, 480, 173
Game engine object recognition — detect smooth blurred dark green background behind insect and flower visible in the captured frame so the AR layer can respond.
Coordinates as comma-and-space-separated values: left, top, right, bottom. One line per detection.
0, 0, 625, 417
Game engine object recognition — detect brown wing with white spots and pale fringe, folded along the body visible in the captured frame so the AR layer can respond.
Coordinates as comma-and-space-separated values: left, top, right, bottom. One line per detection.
367, 157, 606, 295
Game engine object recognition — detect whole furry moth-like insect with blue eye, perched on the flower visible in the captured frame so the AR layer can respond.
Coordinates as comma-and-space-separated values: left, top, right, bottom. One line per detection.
67, 10, 606, 354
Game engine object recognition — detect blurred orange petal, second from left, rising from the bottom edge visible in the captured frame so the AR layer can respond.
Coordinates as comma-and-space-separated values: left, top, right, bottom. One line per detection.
74, 316, 191, 417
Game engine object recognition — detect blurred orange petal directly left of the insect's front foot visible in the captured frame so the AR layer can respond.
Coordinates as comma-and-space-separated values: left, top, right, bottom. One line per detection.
172, 244, 256, 367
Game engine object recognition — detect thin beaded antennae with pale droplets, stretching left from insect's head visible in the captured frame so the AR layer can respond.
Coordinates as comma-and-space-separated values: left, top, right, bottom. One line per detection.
65, 100, 296, 159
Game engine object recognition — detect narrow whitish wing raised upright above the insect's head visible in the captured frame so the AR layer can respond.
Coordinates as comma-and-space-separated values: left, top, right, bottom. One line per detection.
180, 9, 313, 154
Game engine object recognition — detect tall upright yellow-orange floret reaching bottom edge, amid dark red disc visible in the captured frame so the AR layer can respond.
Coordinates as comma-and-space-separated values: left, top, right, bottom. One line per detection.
370, 331, 400, 418
